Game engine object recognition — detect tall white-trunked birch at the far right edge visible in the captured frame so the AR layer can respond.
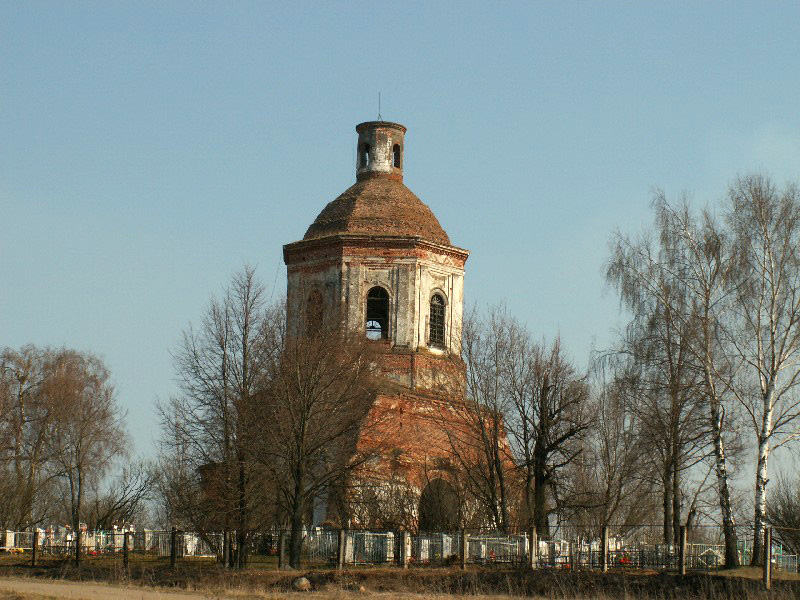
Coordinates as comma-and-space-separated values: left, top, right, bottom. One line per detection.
726, 175, 800, 564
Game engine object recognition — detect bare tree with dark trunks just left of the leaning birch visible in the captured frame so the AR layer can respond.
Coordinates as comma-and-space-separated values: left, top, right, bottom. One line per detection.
607, 219, 708, 543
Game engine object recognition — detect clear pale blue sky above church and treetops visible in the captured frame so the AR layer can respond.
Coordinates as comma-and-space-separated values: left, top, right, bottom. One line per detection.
0, 0, 800, 455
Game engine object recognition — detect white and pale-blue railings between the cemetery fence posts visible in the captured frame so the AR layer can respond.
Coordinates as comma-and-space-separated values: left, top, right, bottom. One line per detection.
0, 528, 800, 573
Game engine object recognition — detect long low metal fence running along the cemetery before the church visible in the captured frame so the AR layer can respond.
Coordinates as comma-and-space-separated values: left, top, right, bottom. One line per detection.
0, 527, 799, 573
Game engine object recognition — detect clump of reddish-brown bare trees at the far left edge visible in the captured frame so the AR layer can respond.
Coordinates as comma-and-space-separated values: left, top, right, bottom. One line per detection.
0, 346, 126, 540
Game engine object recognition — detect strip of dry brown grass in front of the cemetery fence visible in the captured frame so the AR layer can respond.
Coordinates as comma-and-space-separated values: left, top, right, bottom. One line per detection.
0, 558, 800, 600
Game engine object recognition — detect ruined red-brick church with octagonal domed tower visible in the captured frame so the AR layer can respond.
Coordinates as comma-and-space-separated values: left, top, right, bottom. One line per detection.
283, 121, 468, 528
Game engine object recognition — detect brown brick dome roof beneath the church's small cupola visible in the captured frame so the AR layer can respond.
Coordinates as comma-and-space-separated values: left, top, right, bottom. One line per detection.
303, 176, 450, 246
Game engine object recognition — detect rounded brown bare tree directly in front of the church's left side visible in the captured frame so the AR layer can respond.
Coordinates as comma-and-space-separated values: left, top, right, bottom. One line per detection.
249, 326, 379, 568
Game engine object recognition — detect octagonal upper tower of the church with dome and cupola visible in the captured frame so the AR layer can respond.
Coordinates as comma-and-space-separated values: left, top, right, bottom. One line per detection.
284, 121, 468, 389
